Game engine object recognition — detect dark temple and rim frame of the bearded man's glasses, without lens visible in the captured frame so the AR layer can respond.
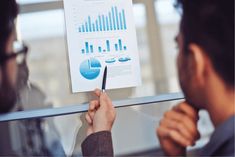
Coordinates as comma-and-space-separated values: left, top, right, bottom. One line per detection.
0, 43, 29, 65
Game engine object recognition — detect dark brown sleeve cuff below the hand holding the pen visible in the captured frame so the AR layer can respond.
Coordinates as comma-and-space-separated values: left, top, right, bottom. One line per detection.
82, 131, 114, 156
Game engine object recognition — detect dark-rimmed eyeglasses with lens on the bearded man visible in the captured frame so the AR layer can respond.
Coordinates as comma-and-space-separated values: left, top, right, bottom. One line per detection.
0, 41, 28, 65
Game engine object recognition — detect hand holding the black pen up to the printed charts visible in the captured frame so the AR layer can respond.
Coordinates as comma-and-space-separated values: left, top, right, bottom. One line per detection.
86, 89, 116, 136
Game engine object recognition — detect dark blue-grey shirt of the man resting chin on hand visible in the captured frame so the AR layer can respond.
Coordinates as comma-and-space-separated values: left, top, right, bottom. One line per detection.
200, 116, 235, 156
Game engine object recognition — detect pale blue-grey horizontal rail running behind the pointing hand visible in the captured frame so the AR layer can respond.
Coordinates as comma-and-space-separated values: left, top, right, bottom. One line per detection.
0, 93, 184, 122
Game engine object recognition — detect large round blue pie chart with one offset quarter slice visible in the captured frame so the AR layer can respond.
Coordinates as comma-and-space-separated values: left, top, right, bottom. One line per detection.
80, 58, 101, 80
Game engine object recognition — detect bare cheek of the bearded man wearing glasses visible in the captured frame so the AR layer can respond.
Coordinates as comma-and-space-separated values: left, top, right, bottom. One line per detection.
6, 59, 18, 87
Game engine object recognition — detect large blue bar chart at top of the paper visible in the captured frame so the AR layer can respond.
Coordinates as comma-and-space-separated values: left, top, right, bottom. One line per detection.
78, 6, 127, 33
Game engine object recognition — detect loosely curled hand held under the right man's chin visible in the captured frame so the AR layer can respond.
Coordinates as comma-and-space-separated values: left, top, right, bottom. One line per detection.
157, 102, 200, 156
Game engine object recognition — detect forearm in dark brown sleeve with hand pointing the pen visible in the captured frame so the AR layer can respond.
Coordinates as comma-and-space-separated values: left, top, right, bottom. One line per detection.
82, 90, 116, 156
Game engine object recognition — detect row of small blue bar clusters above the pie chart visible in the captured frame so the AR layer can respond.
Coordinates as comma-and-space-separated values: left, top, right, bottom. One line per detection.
81, 39, 127, 54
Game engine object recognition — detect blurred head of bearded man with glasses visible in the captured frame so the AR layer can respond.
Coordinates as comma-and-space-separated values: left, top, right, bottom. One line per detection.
0, 0, 28, 113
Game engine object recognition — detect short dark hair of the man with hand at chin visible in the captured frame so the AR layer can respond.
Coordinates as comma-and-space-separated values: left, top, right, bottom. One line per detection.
176, 0, 234, 88
